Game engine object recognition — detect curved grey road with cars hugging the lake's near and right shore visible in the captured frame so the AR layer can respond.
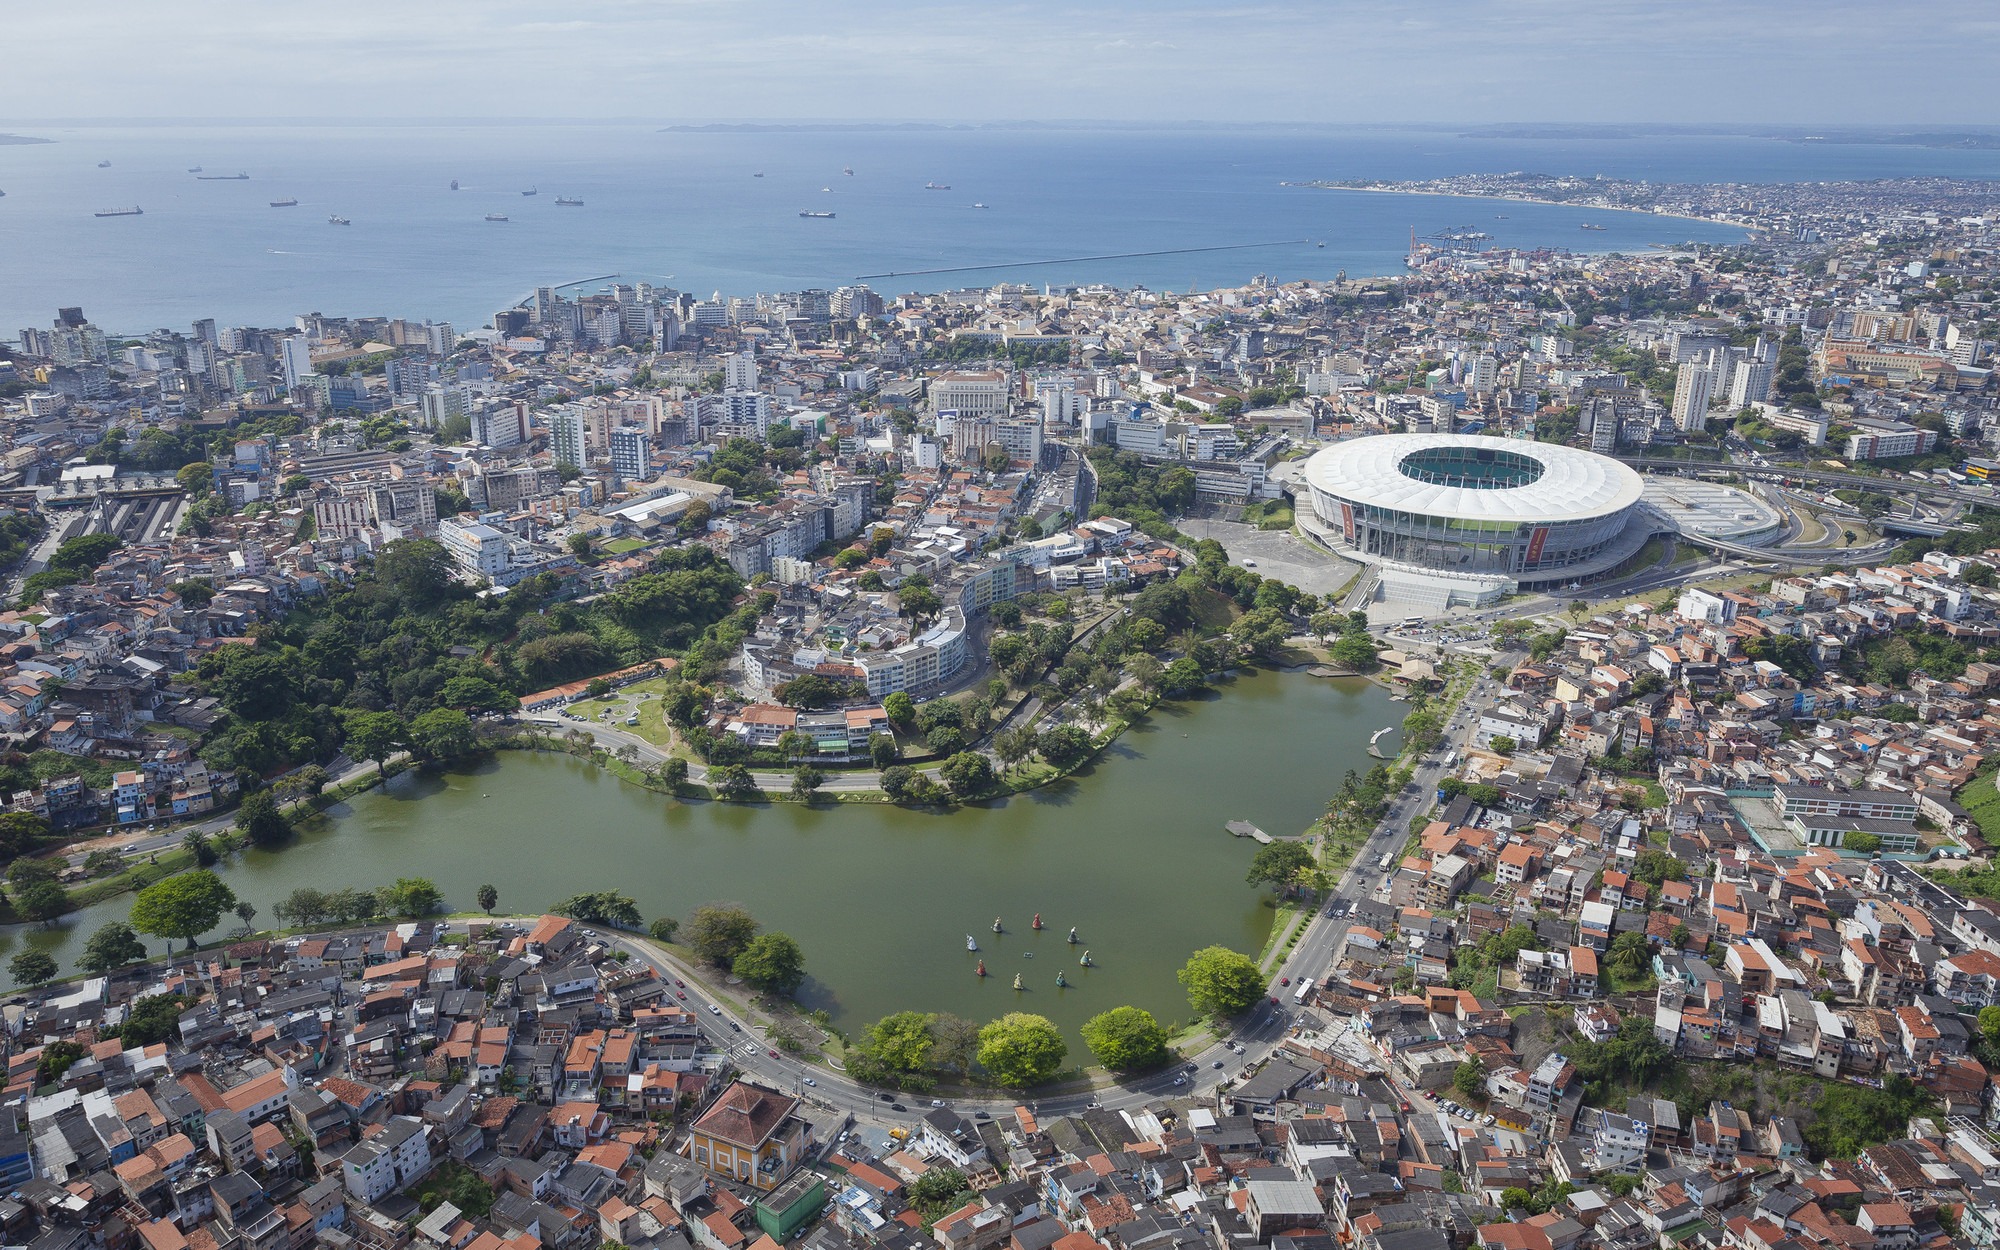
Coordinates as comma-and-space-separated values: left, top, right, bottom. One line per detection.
604, 664, 1494, 1124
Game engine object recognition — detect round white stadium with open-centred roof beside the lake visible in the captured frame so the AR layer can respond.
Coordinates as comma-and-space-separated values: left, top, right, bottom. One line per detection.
1304, 434, 1654, 602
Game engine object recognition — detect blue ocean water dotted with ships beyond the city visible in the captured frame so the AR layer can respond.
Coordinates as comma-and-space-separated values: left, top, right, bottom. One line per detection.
0, 122, 2000, 336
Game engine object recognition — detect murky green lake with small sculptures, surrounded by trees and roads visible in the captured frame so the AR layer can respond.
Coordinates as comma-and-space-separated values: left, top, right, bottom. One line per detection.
0, 672, 1404, 1044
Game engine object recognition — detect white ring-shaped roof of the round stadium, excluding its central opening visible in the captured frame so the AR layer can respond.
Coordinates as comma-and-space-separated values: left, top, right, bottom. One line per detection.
1306, 434, 1644, 524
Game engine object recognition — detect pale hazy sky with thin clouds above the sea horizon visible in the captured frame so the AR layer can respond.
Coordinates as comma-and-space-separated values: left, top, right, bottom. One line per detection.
0, 0, 2000, 126
